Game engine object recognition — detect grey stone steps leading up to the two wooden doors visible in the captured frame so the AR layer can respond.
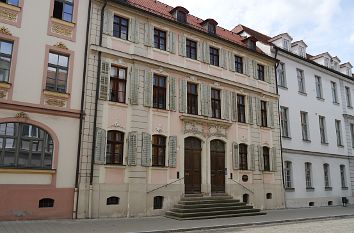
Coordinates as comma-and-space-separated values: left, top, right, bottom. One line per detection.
166, 195, 265, 220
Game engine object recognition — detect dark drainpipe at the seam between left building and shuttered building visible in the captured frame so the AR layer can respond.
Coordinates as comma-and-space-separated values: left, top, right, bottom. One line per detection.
73, 0, 91, 219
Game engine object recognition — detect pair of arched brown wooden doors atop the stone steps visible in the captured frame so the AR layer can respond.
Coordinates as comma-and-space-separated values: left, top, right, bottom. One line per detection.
184, 137, 225, 194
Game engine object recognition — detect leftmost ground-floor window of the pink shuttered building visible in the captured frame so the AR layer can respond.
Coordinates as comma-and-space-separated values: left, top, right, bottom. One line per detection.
106, 130, 124, 165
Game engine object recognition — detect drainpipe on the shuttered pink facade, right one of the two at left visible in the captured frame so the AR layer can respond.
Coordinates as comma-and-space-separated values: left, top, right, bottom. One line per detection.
88, 0, 108, 218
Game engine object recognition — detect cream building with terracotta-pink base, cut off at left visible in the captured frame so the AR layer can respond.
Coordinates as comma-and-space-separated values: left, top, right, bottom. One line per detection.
0, 0, 88, 220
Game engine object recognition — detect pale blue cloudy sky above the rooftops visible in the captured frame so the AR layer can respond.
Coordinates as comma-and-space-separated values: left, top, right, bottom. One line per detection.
160, 0, 354, 65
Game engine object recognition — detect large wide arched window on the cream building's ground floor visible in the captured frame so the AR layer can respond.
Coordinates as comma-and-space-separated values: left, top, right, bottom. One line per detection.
0, 122, 54, 169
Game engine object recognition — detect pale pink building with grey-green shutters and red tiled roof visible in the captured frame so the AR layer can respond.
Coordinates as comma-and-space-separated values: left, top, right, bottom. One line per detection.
78, 0, 284, 218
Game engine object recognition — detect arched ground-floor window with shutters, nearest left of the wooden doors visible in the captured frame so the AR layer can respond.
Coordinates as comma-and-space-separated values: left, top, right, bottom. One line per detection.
152, 135, 166, 167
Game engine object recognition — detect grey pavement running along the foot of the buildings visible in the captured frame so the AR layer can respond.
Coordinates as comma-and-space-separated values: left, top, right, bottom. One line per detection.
0, 206, 354, 233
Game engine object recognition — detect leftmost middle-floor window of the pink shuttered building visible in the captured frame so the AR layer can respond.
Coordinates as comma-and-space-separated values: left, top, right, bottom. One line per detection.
109, 66, 127, 103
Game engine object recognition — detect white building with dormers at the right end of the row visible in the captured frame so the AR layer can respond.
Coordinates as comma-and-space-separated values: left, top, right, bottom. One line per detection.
233, 25, 354, 207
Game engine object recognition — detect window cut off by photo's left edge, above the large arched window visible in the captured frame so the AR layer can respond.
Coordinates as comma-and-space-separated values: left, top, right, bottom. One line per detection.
0, 40, 13, 82
